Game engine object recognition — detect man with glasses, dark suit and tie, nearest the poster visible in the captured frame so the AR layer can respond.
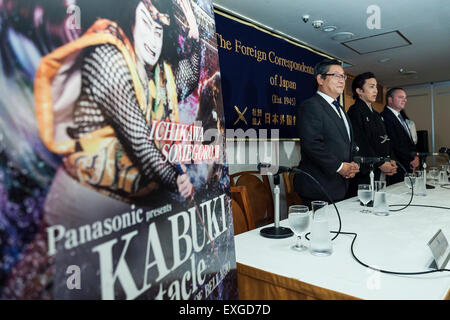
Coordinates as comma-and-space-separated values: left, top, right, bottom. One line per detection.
294, 59, 359, 206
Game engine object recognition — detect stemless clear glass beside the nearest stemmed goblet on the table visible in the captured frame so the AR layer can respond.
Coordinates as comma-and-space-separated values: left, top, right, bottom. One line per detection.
309, 201, 333, 256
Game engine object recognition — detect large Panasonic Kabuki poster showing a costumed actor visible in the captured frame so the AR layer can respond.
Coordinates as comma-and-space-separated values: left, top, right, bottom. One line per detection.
0, 0, 237, 300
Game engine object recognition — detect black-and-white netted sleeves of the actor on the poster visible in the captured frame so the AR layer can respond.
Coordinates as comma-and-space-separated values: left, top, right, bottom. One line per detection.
68, 44, 200, 190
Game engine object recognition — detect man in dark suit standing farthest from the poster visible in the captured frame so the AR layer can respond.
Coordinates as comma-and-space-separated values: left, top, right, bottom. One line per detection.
381, 88, 419, 184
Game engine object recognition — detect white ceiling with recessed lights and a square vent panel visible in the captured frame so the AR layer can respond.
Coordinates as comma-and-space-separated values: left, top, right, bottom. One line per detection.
213, 0, 450, 87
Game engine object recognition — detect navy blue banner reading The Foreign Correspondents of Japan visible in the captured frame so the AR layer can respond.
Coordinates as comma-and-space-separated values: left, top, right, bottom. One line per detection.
215, 12, 325, 139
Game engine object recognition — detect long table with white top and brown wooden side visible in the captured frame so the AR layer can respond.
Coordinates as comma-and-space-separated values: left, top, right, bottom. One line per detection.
235, 183, 450, 299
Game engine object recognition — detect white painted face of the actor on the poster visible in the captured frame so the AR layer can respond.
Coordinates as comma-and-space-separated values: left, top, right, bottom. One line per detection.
133, 2, 163, 67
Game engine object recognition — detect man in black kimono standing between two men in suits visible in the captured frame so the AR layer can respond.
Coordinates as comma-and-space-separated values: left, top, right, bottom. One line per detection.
347, 72, 397, 197
